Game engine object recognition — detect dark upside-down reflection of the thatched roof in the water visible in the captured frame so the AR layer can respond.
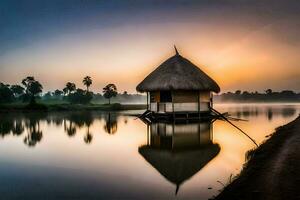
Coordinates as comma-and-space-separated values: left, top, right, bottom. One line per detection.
139, 144, 220, 193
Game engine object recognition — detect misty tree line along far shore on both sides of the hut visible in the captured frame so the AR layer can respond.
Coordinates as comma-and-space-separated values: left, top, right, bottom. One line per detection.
0, 76, 300, 104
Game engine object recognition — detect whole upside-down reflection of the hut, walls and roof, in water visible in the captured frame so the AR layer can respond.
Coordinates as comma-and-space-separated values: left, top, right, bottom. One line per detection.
139, 122, 220, 194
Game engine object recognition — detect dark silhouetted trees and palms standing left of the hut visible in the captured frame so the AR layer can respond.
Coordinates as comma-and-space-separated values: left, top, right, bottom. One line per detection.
0, 76, 118, 104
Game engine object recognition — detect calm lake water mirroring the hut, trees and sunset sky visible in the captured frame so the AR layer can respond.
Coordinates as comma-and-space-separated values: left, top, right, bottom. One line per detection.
0, 104, 300, 199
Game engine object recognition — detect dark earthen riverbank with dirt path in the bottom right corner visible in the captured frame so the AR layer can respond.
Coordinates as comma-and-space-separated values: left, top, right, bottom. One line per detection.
215, 116, 300, 200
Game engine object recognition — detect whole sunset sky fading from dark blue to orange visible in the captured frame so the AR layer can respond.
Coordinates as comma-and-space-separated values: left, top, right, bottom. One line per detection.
0, 0, 300, 93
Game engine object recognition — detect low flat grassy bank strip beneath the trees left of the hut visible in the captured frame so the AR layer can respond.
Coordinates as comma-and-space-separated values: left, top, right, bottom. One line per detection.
0, 104, 147, 113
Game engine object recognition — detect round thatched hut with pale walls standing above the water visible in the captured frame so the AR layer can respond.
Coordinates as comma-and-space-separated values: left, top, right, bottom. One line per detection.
136, 47, 220, 114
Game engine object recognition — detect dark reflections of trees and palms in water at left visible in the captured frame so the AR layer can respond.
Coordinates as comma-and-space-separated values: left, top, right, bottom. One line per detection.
0, 112, 118, 147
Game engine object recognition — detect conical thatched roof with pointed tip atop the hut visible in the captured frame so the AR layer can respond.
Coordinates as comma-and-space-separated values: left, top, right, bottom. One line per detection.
136, 47, 220, 93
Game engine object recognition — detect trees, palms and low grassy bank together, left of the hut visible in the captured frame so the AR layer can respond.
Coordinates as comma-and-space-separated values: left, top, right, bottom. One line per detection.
0, 76, 146, 112
